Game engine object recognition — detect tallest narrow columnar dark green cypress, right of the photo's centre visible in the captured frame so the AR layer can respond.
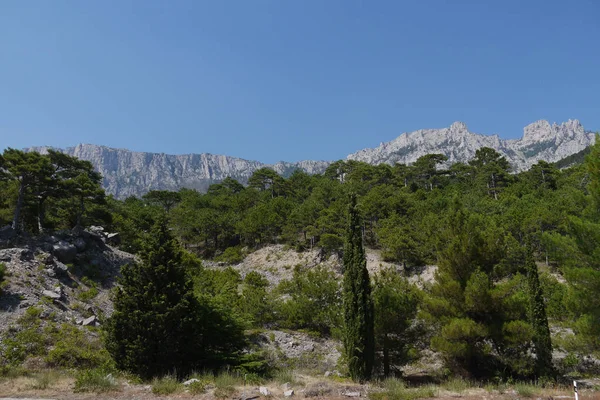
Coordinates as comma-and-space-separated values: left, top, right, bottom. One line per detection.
343, 195, 375, 382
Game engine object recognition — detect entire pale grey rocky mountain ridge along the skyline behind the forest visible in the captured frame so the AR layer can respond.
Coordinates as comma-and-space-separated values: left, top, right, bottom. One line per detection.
28, 120, 595, 199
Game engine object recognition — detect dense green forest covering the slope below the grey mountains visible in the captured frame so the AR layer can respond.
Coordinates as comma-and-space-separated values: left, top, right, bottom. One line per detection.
0, 140, 600, 379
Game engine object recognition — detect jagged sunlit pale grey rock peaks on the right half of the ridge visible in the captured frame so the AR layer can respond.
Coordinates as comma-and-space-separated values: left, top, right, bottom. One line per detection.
348, 120, 595, 171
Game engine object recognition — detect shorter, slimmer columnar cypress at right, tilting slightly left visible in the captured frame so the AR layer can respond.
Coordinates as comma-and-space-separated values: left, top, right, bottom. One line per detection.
525, 249, 555, 378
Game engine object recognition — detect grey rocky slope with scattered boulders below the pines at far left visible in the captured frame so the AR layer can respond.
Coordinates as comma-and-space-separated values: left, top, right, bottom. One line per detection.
0, 229, 135, 334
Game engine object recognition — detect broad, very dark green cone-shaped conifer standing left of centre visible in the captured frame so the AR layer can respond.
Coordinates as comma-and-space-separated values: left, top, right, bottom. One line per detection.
106, 219, 243, 378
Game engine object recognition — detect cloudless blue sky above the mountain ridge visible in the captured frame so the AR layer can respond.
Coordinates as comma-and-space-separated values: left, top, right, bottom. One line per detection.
0, 0, 600, 162
